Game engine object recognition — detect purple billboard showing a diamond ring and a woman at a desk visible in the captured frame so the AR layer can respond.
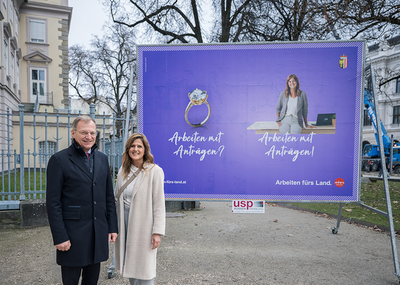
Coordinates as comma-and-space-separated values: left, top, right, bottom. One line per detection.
138, 41, 364, 202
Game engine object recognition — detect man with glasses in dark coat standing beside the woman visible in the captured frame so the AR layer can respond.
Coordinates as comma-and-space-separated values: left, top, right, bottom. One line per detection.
46, 116, 118, 285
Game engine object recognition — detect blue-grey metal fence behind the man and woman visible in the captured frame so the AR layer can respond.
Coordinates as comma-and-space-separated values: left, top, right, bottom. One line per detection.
0, 104, 134, 207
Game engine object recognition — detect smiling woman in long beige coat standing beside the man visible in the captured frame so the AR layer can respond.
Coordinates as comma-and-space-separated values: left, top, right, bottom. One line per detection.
115, 133, 165, 285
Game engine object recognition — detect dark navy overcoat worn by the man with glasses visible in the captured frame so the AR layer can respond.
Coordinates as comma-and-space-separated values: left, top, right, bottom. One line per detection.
46, 143, 118, 266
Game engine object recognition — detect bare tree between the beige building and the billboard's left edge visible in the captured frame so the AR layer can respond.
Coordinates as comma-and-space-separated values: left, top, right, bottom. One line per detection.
69, 24, 136, 133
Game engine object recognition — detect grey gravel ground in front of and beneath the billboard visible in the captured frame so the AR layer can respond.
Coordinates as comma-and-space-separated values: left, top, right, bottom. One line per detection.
0, 201, 400, 285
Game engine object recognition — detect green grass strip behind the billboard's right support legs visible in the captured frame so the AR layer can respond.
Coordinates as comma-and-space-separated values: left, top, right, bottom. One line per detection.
291, 181, 400, 229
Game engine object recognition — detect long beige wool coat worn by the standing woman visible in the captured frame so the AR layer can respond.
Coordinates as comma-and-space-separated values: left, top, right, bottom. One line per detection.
115, 163, 165, 280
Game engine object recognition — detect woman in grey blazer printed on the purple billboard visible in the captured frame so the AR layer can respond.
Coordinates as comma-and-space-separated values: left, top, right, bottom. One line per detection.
276, 74, 315, 134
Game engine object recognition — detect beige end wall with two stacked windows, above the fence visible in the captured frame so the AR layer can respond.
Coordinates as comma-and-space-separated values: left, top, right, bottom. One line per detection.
20, 0, 72, 111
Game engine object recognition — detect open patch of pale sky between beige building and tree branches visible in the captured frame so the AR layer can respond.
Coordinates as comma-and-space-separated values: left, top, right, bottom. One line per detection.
68, 0, 109, 47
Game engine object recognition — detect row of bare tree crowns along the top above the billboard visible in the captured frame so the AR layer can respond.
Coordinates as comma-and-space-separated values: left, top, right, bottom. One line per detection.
103, 0, 400, 43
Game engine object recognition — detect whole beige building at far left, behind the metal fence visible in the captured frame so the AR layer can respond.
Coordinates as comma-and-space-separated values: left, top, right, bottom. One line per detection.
0, 0, 72, 171
